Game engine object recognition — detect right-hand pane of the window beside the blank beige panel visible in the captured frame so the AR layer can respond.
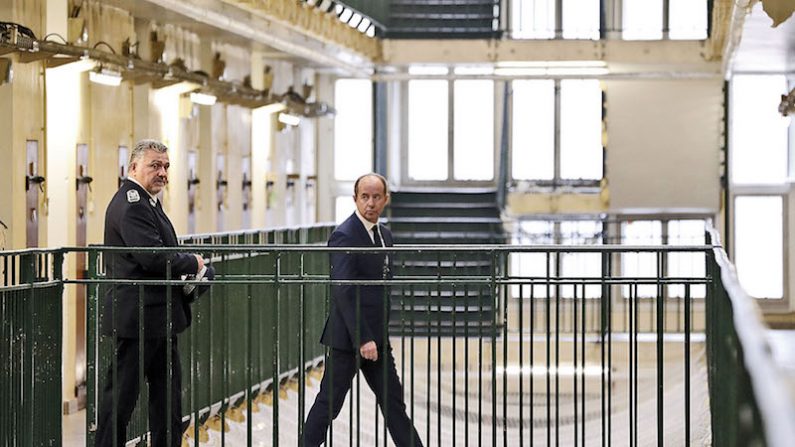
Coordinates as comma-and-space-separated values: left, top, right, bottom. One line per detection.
560, 79, 603, 180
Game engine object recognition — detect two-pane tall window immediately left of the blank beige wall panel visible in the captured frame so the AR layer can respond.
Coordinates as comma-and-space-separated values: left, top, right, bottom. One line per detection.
511, 80, 604, 184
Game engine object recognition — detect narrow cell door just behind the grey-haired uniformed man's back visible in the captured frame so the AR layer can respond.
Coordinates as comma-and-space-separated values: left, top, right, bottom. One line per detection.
75, 144, 93, 396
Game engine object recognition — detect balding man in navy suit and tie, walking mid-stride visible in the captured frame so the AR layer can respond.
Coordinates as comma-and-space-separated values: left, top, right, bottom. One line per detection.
303, 174, 422, 447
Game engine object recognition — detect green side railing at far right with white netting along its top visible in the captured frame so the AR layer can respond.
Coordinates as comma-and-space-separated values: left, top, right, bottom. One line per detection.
706, 231, 795, 447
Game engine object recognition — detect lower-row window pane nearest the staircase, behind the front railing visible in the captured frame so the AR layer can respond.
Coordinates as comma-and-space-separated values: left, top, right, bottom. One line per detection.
508, 220, 555, 298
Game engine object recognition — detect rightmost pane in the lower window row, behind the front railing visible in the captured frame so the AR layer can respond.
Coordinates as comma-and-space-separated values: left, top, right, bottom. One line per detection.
668, 219, 707, 298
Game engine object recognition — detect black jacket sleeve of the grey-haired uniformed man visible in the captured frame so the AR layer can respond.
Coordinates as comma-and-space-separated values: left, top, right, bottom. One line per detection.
121, 204, 199, 278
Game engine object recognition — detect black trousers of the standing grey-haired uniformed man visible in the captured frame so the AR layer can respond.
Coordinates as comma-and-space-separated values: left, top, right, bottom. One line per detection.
95, 337, 183, 447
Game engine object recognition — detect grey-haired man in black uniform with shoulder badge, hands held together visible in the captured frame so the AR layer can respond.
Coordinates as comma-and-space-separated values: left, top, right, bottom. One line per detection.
96, 140, 214, 447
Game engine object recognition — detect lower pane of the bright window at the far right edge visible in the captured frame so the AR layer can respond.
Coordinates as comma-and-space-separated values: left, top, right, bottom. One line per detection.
734, 196, 784, 298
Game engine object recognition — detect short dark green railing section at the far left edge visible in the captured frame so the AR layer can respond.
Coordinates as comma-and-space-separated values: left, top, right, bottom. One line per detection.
0, 250, 63, 447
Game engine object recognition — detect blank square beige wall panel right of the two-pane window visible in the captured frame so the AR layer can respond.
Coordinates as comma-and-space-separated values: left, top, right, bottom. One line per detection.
606, 78, 723, 213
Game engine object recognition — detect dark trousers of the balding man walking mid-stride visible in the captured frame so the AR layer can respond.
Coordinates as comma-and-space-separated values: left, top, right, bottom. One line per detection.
303, 346, 422, 447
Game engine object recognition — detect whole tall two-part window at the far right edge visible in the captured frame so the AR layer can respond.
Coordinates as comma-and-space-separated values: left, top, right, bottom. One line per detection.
729, 75, 790, 299
